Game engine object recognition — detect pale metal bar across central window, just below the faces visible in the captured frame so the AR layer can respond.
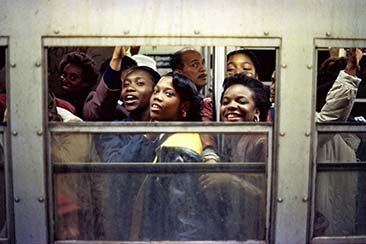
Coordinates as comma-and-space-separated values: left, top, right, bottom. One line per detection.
49, 122, 272, 133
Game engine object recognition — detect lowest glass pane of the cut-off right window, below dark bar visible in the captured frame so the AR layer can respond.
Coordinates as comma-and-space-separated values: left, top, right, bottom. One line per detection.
314, 171, 366, 236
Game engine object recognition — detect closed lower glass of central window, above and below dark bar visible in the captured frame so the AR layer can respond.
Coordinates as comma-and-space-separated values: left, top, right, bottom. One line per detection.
51, 133, 268, 240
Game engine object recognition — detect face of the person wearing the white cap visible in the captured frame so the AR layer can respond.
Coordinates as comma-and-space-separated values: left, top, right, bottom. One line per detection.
121, 69, 154, 112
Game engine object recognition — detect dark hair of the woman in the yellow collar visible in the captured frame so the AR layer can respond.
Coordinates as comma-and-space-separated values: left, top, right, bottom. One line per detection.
164, 72, 202, 121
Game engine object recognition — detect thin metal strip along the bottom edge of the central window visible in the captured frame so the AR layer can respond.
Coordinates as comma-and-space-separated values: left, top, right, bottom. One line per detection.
55, 240, 267, 244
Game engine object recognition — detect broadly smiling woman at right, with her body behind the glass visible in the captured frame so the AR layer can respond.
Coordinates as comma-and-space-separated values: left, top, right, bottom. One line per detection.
199, 73, 270, 240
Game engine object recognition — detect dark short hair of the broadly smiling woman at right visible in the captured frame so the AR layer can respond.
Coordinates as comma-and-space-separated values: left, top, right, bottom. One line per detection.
220, 73, 271, 121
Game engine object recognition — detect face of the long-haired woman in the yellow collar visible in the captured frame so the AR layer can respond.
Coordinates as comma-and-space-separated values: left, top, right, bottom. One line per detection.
150, 77, 182, 121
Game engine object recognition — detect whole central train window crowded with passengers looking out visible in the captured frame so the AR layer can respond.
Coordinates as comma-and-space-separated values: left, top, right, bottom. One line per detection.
45, 39, 278, 243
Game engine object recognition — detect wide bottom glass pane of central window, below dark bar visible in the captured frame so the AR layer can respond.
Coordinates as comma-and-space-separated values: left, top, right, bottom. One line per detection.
54, 173, 266, 240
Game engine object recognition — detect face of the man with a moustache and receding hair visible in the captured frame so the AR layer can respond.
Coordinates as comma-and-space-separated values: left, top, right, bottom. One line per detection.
177, 50, 207, 90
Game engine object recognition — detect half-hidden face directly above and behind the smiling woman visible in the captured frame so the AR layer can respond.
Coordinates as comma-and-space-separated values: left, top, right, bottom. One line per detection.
226, 53, 258, 78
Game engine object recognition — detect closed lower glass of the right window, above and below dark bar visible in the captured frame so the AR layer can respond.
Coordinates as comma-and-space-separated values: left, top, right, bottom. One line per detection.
314, 133, 366, 236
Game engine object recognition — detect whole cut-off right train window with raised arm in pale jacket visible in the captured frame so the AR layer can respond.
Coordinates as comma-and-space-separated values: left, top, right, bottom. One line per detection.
312, 45, 366, 243
